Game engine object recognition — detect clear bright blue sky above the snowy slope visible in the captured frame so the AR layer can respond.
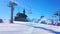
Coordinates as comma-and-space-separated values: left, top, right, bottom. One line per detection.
0, 0, 60, 19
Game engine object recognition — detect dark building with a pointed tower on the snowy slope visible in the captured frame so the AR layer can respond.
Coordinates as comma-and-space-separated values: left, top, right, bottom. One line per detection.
14, 9, 27, 21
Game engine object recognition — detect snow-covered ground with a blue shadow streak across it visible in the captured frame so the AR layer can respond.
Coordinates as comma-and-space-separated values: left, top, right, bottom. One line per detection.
0, 21, 60, 34
